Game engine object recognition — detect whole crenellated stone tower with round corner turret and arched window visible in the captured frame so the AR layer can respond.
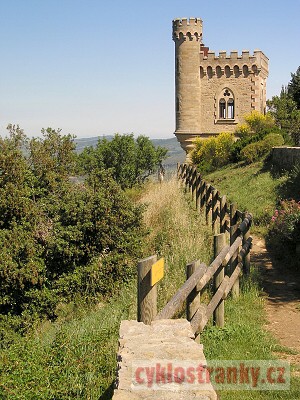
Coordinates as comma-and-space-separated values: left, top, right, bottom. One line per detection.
173, 18, 269, 151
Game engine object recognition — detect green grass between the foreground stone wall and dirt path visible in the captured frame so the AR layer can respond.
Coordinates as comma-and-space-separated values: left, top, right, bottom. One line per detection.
201, 270, 300, 400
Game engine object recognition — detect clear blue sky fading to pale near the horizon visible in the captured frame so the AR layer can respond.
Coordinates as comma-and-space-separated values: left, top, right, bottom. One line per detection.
0, 0, 300, 138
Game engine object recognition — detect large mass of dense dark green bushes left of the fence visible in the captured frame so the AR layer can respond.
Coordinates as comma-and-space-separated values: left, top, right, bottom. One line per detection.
0, 126, 144, 336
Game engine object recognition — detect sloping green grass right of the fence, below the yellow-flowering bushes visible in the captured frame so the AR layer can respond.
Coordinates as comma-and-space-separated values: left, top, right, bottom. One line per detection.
205, 163, 287, 231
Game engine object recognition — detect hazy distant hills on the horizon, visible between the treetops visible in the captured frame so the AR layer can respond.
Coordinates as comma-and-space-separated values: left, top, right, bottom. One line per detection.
75, 135, 185, 169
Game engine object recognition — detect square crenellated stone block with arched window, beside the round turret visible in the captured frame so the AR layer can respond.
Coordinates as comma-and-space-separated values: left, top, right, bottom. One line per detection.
200, 50, 268, 135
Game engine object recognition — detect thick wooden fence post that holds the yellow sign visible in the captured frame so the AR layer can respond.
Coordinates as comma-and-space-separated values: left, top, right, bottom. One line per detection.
137, 255, 157, 325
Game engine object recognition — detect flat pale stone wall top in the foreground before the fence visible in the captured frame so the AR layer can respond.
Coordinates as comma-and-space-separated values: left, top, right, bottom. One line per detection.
113, 319, 217, 400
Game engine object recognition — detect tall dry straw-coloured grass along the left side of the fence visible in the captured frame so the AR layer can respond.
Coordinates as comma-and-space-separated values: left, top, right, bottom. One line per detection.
141, 178, 212, 312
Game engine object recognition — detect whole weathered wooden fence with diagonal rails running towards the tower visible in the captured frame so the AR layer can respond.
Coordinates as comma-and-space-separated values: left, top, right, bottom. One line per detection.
138, 164, 252, 336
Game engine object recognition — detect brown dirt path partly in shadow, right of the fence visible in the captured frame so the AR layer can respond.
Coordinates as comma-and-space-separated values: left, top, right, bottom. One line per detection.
251, 236, 300, 366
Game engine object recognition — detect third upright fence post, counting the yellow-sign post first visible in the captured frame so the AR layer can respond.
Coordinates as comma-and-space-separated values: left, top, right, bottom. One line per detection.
213, 233, 226, 328
